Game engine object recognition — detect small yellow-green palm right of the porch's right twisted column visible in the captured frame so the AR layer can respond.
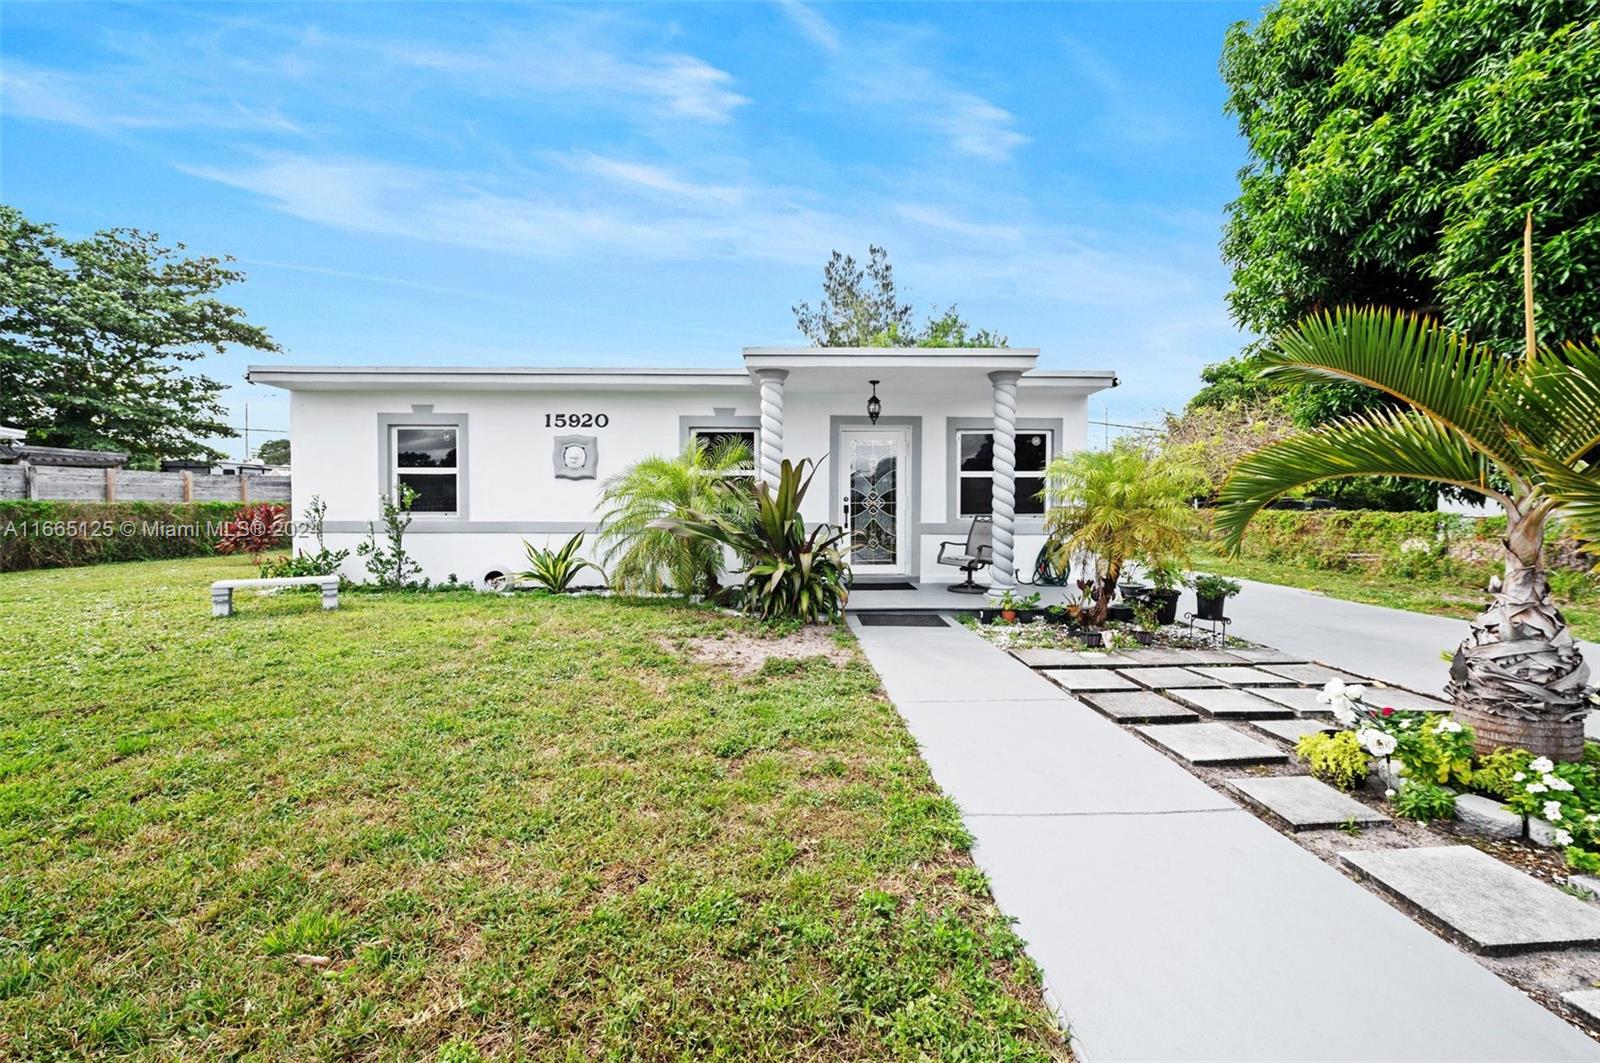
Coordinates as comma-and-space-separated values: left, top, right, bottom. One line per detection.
1045, 440, 1205, 623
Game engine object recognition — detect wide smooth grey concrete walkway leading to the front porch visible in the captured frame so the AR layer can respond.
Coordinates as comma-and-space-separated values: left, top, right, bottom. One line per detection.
853, 617, 1600, 1063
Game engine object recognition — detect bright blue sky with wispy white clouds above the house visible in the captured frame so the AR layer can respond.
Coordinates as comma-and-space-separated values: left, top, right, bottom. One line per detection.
0, 3, 1259, 451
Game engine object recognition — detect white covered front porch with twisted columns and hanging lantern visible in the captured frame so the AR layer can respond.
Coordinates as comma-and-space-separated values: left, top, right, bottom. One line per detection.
744, 347, 1117, 598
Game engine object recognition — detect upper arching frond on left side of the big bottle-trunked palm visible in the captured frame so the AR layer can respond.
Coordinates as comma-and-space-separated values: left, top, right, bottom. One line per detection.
1262, 307, 1520, 474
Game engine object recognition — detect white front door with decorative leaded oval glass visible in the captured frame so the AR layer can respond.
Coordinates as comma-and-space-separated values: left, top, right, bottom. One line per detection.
838, 427, 910, 575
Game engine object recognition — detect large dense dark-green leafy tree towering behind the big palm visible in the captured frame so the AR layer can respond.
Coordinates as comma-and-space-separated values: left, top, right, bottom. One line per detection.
1222, 0, 1600, 352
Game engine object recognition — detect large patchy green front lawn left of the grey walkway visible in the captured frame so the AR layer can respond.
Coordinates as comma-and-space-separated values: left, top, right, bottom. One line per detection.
0, 559, 1066, 1060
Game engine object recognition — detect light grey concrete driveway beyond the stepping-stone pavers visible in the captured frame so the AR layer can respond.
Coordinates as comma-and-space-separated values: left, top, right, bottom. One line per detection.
1227, 580, 1600, 696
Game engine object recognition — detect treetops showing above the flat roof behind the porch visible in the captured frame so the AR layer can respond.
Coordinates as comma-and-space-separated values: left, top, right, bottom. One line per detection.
792, 243, 1006, 347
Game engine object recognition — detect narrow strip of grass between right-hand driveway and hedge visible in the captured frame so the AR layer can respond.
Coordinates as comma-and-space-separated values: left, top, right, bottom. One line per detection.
1195, 552, 1600, 640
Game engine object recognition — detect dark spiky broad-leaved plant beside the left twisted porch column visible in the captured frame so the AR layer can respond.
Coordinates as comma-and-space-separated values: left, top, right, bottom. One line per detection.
667, 458, 850, 621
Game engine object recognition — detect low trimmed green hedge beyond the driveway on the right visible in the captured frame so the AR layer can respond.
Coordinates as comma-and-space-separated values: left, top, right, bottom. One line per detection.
1222, 509, 1594, 576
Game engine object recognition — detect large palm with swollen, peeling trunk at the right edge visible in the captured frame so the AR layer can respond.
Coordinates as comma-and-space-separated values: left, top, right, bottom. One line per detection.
1216, 288, 1600, 760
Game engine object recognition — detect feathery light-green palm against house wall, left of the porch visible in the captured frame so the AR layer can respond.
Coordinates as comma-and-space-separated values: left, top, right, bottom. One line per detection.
600, 435, 752, 596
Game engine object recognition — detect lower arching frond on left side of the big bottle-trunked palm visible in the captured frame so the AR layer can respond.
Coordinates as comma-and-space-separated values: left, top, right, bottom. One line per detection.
1216, 410, 1506, 551
